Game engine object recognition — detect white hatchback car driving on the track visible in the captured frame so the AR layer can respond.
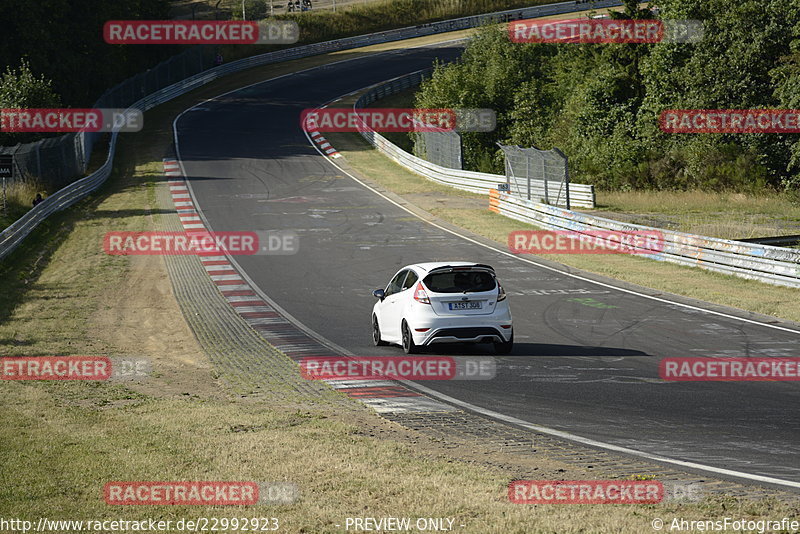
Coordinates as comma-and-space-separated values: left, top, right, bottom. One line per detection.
372, 261, 514, 354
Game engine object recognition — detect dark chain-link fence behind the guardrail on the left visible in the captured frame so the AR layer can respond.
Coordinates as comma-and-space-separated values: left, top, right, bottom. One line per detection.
0, 45, 217, 190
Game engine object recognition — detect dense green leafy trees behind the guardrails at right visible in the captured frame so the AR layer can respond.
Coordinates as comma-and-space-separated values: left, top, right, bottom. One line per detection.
416, 0, 800, 191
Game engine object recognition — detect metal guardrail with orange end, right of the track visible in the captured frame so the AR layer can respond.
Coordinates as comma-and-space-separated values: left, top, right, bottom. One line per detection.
489, 190, 800, 287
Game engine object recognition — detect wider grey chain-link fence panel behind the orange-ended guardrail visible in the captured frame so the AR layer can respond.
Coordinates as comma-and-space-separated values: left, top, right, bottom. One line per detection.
498, 143, 570, 209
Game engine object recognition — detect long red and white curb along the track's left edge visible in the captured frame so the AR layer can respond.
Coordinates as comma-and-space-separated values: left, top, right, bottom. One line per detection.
164, 157, 456, 413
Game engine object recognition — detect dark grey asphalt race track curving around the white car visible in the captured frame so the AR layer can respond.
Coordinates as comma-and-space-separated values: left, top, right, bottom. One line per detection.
176, 47, 800, 489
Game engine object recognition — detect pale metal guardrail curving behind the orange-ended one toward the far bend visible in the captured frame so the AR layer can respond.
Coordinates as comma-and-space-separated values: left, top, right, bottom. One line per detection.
353, 73, 595, 208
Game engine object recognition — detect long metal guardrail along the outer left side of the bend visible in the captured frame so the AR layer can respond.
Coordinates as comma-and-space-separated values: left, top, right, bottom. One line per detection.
0, 0, 622, 259
